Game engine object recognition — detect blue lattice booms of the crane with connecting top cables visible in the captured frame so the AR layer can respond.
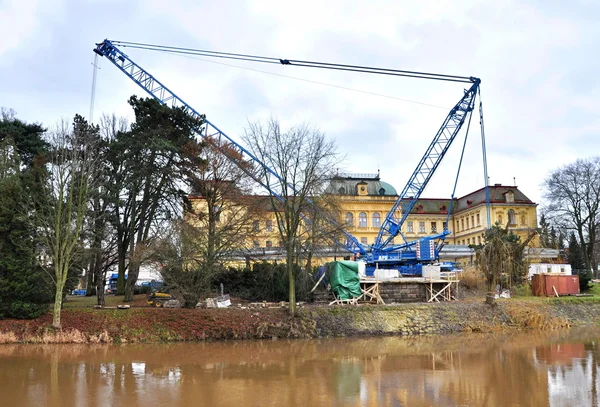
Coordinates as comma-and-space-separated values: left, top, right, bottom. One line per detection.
94, 40, 483, 260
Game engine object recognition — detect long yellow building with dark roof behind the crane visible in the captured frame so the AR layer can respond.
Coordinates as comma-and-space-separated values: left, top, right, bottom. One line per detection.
190, 174, 537, 260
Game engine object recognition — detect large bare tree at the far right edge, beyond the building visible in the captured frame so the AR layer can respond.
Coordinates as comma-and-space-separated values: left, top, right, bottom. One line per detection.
543, 157, 600, 270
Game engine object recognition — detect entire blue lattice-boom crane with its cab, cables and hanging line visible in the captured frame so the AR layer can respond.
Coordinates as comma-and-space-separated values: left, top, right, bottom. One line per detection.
94, 40, 490, 274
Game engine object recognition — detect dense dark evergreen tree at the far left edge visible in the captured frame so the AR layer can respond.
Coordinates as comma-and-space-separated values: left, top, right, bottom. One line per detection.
0, 110, 52, 318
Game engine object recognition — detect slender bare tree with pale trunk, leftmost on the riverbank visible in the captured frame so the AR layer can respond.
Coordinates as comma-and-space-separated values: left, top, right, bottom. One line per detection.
36, 115, 98, 328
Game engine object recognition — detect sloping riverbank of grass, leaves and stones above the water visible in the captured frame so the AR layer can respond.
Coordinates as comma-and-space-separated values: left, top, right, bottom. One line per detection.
0, 299, 600, 343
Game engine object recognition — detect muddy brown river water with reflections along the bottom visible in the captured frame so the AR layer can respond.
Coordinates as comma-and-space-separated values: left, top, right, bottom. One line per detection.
0, 329, 600, 407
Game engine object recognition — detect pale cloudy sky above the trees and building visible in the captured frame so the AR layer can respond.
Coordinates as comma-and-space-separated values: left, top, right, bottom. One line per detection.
0, 0, 600, 207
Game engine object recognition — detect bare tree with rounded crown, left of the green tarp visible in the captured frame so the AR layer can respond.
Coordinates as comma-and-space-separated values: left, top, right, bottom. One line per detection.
243, 119, 338, 315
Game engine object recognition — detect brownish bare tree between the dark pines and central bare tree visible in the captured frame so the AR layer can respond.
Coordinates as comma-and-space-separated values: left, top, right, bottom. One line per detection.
158, 139, 260, 307
